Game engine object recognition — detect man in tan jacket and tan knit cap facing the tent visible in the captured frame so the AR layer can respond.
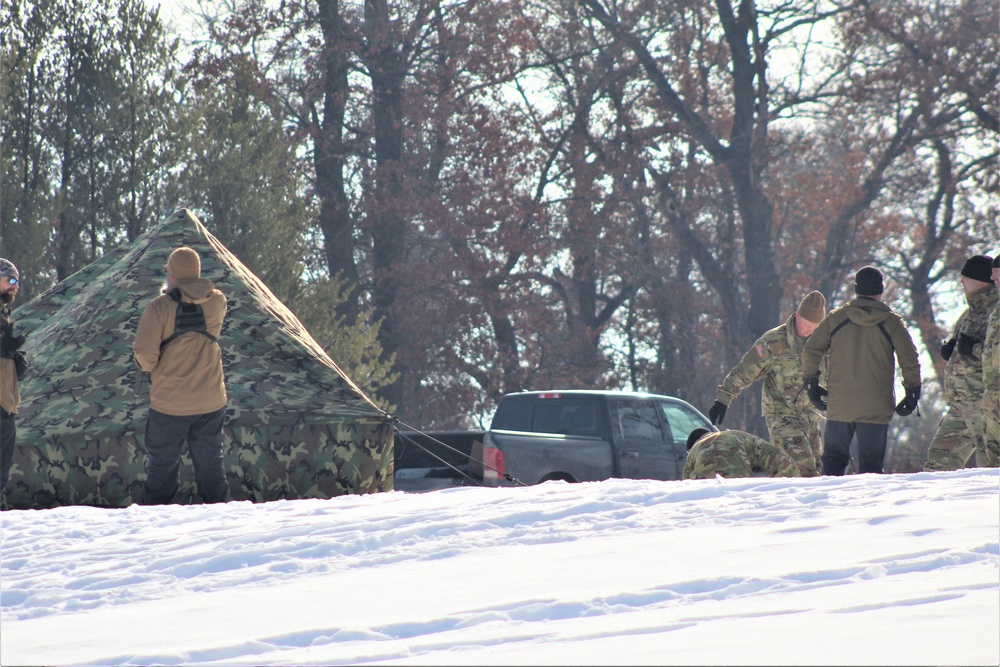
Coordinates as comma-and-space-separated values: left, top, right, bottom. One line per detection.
133, 247, 231, 505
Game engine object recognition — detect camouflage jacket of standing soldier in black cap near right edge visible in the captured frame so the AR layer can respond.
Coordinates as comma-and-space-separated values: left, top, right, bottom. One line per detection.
944, 285, 1000, 410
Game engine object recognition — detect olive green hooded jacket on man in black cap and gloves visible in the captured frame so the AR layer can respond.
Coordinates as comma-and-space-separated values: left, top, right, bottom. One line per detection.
802, 297, 920, 424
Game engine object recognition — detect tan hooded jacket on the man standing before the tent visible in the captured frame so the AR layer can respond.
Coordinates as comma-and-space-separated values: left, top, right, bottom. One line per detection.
133, 278, 227, 416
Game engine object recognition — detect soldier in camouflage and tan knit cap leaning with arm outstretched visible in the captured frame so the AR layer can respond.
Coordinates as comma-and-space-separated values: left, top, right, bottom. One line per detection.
708, 291, 826, 477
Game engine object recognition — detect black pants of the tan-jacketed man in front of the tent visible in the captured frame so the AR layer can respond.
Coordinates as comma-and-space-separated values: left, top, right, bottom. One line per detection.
142, 408, 231, 505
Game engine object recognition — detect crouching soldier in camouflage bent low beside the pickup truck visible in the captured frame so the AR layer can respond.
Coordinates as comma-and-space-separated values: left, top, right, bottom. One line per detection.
681, 428, 802, 479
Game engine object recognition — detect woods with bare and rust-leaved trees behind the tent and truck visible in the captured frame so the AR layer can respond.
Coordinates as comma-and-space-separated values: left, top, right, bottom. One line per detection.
0, 0, 1000, 456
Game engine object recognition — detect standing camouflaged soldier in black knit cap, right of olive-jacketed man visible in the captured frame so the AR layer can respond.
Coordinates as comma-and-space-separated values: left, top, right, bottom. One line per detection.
924, 255, 998, 471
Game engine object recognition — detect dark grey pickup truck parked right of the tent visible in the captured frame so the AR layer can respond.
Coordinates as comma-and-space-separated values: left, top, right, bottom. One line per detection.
395, 390, 718, 490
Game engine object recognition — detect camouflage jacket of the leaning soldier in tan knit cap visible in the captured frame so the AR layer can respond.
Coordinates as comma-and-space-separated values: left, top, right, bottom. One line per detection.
717, 314, 820, 418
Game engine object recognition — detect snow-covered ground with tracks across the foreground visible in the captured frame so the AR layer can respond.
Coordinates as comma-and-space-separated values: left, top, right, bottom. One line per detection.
0, 469, 1000, 665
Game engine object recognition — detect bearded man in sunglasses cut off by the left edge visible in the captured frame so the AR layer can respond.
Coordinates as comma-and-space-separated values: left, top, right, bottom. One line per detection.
0, 257, 24, 507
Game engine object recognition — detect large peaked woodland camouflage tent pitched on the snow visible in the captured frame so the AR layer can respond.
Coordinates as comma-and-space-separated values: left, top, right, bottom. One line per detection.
7, 209, 393, 508
